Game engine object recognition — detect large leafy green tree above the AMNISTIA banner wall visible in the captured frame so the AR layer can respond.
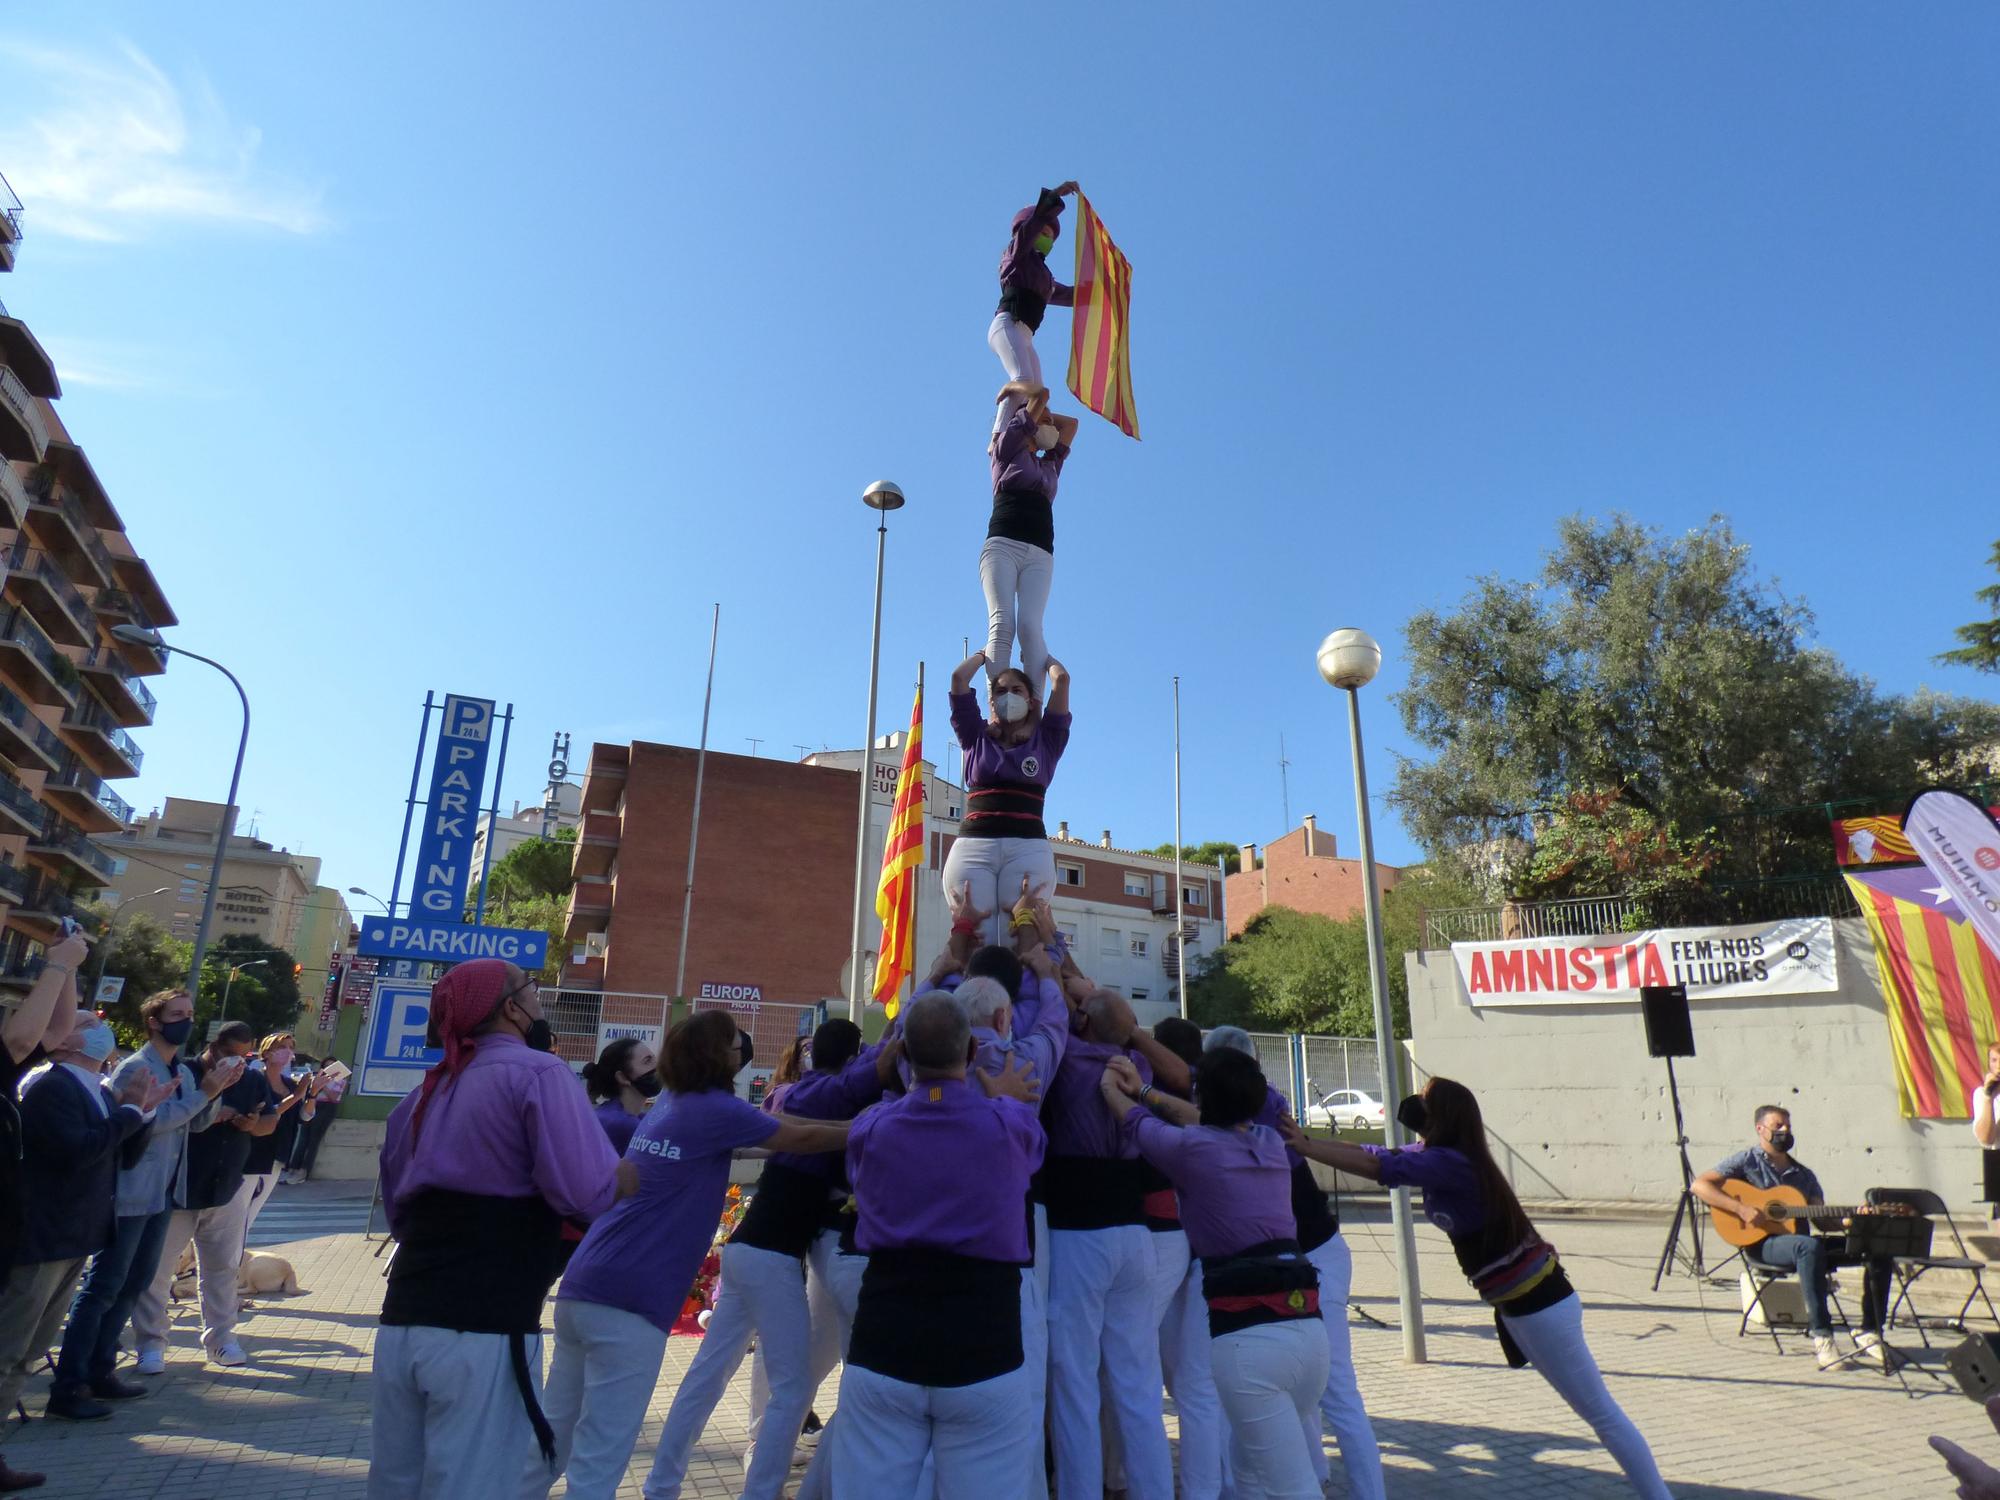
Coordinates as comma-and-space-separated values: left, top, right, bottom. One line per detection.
1390, 516, 2000, 896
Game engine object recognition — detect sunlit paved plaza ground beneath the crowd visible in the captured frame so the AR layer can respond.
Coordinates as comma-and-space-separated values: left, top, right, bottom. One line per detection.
6, 1184, 2000, 1500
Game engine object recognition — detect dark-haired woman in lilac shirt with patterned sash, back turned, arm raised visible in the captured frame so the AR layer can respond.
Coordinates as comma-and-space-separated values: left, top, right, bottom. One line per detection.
1102, 1050, 1328, 1500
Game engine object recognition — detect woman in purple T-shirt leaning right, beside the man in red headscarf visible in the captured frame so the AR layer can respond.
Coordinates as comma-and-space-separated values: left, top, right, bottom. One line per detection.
522, 1010, 848, 1500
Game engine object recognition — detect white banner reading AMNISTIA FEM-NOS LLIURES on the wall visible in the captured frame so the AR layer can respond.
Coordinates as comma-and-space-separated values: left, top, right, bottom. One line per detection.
1452, 916, 1840, 1006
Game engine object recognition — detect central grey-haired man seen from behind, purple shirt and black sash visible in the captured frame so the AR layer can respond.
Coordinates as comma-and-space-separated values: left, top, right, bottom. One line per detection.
832, 994, 1046, 1500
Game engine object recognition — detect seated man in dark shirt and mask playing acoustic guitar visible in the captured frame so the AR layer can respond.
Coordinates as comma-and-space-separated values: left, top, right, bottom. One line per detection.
1694, 1104, 1890, 1370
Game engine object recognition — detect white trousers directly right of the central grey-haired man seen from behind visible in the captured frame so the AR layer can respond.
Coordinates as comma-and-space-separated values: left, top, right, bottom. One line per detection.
1048, 1224, 1174, 1500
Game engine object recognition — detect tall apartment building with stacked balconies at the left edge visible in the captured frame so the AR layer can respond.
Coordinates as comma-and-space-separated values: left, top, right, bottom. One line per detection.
0, 180, 174, 988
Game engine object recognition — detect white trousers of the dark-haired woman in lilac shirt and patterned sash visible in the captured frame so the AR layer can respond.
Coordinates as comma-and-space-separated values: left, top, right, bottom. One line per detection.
1208, 1318, 1326, 1500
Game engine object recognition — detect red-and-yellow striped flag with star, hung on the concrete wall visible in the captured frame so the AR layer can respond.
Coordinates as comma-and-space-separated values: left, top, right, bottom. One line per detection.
1846, 864, 2000, 1120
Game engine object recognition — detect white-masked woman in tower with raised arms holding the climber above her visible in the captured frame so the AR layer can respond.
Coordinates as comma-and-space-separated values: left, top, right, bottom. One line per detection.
944, 652, 1070, 944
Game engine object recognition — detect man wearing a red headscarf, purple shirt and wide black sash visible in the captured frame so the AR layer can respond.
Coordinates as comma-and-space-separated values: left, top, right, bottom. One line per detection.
368, 958, 636, 1500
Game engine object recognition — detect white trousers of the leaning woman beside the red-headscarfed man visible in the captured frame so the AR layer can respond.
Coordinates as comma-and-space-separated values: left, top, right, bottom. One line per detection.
520, 1298, 666, 1500
